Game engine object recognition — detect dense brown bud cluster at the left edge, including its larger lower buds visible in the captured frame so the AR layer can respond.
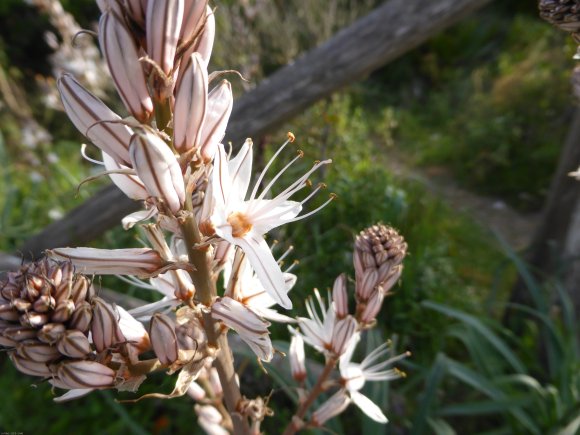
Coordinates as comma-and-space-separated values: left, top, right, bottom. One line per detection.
0, 259, 133, 389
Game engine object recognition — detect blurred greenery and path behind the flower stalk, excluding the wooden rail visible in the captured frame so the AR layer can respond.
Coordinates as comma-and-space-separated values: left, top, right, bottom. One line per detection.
0, 0, 580, 434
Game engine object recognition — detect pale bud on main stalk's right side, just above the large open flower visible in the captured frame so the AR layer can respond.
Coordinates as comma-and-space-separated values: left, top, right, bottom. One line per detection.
201, 80, 234, 161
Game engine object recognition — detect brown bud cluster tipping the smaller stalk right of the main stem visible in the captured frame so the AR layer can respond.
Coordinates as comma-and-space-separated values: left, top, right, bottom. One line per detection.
354, 224, 407, 325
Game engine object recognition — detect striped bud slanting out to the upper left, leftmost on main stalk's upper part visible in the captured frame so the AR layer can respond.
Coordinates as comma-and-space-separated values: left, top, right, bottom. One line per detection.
57, 74, 132, 163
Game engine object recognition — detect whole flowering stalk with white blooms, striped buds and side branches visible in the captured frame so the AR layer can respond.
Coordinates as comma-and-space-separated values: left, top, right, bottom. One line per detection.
0, 0, 406, 435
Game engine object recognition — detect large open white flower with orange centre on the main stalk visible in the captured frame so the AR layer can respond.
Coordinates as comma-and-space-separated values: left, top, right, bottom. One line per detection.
202, 139, 331, 309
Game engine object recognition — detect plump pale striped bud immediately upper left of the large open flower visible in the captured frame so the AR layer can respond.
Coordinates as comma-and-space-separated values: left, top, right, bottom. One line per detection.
129, 131, 185, 213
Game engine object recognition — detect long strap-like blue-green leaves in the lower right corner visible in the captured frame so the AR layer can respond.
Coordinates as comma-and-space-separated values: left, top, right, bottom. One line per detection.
412, 246, 580, 434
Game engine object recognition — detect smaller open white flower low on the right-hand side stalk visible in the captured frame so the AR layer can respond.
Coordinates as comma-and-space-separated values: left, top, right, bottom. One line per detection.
339, 334, 409, 423
